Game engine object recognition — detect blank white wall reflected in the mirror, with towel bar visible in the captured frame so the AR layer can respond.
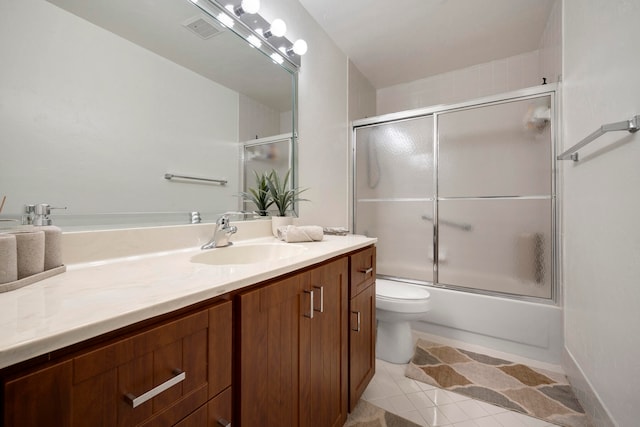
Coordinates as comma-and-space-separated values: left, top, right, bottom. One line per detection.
0, 0, 239, 214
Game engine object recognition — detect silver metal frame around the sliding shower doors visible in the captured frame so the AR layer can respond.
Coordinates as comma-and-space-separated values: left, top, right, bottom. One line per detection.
349, 83, 561, 305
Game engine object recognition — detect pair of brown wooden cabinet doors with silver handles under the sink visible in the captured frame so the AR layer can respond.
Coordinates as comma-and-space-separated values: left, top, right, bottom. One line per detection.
234, 257, 348, 427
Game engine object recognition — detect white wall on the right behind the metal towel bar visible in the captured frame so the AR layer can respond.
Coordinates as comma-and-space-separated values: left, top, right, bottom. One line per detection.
562, 0, 640, 426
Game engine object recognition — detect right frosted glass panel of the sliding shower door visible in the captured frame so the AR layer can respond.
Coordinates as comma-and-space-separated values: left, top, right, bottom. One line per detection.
437, 96, 554, 298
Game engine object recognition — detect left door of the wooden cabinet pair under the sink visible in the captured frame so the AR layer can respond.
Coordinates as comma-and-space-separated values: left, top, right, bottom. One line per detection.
234, 274, 309, 427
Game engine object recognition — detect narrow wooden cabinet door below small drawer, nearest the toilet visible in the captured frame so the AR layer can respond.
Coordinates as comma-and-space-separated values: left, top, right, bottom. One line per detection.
349, 283, 376, 411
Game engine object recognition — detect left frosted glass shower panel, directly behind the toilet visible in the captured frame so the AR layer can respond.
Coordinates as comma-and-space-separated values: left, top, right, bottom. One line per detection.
354, 116, 434, 282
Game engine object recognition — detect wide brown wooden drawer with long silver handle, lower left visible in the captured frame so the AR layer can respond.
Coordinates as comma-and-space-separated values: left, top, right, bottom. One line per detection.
73, 302, 231, 426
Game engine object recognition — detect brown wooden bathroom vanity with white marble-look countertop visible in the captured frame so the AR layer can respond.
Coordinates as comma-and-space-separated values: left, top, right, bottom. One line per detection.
0, 226, 375, 427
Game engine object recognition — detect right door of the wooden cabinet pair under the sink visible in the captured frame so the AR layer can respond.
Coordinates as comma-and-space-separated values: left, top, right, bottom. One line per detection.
300, 257, 349, 427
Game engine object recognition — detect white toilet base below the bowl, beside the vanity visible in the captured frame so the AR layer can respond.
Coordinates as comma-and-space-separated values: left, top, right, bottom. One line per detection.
376, 320, 414, 364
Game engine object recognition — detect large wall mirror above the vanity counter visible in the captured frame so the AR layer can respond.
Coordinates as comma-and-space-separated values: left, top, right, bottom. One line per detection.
0, 0, 296, 230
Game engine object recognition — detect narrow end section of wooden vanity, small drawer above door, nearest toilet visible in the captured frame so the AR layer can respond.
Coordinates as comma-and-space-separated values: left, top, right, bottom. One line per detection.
349, 246, 376, 412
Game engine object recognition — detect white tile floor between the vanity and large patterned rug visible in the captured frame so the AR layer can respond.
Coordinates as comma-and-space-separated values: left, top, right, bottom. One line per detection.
363, 360, 555, 427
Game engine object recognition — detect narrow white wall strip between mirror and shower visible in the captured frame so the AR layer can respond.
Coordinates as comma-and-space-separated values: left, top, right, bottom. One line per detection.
260, 0, 349, 226
